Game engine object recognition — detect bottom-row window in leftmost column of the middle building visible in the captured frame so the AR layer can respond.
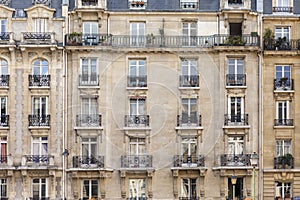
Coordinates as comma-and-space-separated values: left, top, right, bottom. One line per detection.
82, 180, 98, 200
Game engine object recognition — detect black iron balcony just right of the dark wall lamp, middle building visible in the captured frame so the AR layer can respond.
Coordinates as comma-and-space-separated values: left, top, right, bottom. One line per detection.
73, 156, 104, 168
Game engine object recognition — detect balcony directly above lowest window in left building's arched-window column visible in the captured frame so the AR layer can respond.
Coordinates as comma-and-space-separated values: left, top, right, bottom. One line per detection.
22, 155, 54, 166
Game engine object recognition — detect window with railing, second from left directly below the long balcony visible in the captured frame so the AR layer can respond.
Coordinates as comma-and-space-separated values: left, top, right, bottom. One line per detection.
128, 60, 147, 87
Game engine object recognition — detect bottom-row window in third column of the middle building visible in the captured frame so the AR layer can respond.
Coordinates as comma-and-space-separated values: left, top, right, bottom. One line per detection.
180, 178, 198, 199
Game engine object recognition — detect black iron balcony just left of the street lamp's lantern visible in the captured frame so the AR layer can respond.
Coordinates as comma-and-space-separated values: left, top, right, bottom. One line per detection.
221, 154, 251, 166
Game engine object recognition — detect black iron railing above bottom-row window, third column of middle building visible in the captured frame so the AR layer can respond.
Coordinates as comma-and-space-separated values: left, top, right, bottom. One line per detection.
174, 155, 205, 167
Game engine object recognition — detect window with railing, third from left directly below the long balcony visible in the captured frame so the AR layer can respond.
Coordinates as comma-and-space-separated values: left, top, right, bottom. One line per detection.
180, 59, 199, 87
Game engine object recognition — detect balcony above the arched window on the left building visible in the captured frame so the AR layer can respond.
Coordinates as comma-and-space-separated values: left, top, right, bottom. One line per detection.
21, 32, 56, 45
